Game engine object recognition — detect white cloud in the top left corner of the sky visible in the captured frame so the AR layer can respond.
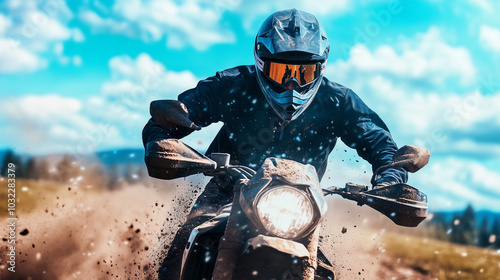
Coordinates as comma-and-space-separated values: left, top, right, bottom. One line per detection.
0, 0, 83, 73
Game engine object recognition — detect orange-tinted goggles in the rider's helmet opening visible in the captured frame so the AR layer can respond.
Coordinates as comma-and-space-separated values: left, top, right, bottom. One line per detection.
264, 61, 324, 86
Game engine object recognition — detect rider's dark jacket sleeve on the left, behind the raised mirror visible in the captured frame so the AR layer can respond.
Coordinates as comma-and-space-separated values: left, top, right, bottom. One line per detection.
142, 72, 228, 146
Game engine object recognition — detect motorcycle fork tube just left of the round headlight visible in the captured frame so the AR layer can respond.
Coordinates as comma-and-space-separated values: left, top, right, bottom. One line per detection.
212, 184, 244, 280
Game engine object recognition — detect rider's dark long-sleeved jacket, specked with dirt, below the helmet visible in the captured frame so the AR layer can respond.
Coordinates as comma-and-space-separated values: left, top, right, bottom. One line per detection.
142, 65, 407, 184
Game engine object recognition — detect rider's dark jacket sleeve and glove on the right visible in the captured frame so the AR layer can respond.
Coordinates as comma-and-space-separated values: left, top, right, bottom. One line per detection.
340, 89, 408, 185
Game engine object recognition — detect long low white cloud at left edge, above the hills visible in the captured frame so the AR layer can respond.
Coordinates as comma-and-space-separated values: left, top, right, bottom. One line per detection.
0, 94, 135, 154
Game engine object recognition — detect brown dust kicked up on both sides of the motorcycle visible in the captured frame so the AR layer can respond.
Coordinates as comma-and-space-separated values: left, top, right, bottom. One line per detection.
0, 180, 426, 280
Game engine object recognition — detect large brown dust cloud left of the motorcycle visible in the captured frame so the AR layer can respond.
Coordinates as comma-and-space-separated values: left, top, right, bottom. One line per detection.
0, 175, 207, 280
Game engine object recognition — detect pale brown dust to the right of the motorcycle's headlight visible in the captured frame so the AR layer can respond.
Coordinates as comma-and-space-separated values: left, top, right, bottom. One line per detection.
322, 198, 434, 280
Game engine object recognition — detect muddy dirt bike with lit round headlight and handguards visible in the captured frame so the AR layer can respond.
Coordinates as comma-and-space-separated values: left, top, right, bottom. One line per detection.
145, 139, 430, 280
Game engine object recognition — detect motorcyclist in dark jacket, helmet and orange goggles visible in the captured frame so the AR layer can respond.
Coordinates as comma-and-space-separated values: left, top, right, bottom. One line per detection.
143, 9, 407, 279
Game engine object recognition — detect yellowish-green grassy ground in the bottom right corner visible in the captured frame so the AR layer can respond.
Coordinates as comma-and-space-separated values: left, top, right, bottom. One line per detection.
383, 235, 500, 280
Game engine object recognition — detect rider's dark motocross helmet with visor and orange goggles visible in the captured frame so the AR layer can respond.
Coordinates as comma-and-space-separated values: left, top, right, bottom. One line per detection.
254, 9, 330, 121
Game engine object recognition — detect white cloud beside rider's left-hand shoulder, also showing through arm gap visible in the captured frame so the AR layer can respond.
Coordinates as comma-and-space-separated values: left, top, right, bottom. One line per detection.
91, 53, 221, 150
